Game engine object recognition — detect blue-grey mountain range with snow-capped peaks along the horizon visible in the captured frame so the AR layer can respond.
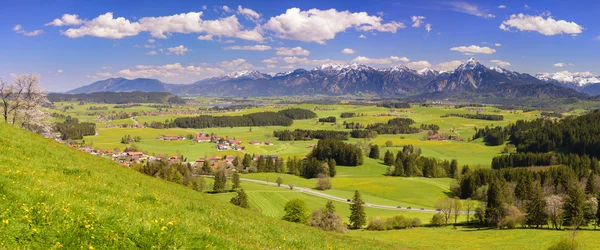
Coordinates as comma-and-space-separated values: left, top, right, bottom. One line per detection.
67, 58, 600, 98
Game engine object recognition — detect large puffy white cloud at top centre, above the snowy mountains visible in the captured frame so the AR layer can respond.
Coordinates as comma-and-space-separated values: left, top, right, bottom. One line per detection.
263, 8, 405, 44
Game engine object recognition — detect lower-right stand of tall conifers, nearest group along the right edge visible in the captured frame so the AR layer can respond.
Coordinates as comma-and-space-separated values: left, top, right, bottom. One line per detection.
454, 167, 600, 229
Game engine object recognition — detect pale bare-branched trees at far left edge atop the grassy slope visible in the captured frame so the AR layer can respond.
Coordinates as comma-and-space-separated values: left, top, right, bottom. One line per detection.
0, 74, 52, 133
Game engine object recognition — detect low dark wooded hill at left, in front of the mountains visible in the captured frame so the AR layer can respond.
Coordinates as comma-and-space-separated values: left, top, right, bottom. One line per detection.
48, 91, 185, 104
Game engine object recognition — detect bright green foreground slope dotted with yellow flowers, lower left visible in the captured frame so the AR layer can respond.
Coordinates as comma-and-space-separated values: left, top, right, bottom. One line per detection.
0, 124, 392, 249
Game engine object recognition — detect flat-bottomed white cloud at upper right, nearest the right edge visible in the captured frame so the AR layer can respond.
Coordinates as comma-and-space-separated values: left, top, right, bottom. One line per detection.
500, 13, 583, 36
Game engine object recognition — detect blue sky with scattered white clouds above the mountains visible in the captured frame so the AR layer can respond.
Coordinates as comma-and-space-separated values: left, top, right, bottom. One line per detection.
0, 0, 600, 91
